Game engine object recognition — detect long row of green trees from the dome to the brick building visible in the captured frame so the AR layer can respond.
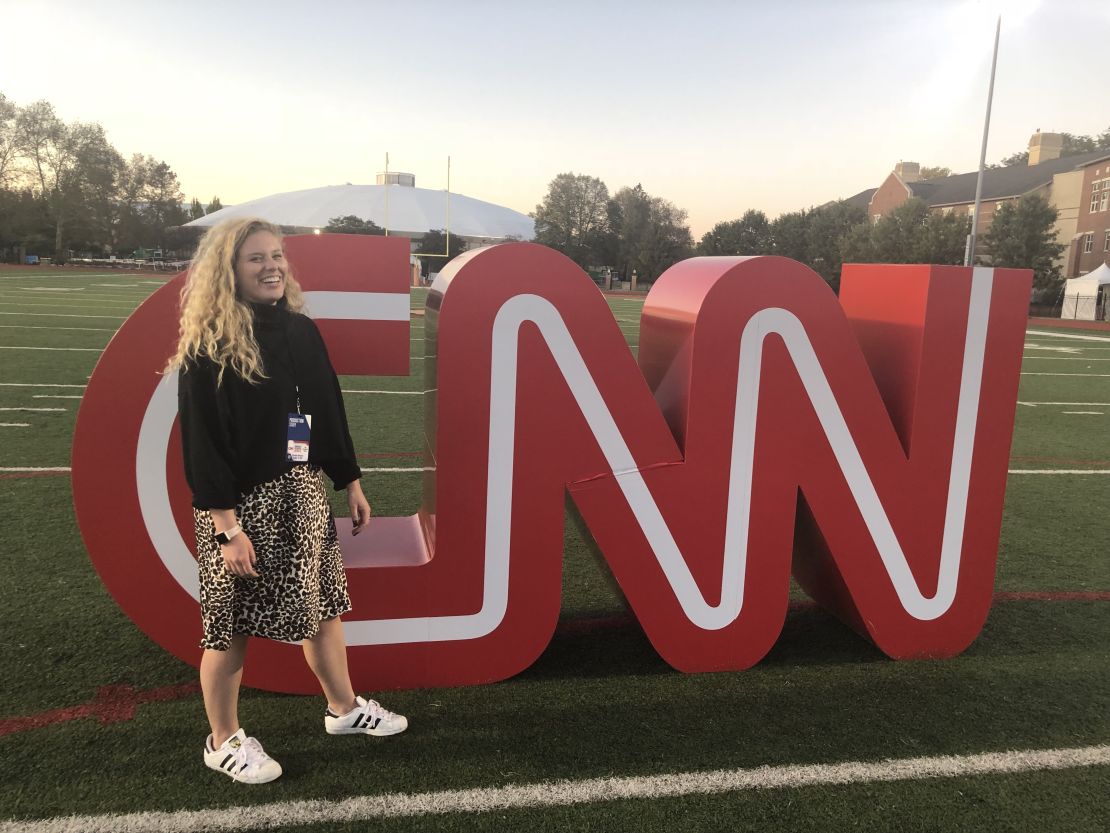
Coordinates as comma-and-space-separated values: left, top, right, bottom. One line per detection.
532, 168, 1063, 293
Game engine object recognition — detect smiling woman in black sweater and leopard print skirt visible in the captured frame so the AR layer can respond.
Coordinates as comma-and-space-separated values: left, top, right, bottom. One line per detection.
168, 218, 408, 783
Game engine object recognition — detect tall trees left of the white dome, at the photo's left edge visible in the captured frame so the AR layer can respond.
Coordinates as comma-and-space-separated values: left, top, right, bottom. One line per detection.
0, 93, 220, 262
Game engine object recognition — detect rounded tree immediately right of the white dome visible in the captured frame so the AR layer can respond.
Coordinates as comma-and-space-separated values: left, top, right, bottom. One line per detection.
532, 172, 609, 268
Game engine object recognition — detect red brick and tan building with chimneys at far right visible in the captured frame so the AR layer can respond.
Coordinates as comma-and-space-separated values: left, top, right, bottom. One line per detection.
847, 132, 1110, 265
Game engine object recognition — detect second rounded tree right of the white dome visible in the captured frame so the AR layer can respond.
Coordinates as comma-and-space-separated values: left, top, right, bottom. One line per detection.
607, 184, 694, 282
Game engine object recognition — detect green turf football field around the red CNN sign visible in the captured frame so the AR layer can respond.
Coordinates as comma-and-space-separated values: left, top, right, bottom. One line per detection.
0, 268, 1110, 833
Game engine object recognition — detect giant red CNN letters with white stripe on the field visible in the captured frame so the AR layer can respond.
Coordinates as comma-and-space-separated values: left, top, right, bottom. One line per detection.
73, 234, 1031, 693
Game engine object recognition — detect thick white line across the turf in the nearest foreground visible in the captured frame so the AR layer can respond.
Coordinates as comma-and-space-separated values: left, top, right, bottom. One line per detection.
0, 745, 1110, 833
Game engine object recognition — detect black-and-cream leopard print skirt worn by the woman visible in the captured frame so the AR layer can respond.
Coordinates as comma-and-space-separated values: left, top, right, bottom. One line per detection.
193, 465, 351, 651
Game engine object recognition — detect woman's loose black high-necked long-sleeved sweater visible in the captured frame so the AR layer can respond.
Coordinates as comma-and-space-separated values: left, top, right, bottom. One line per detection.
178, 299, 362, 509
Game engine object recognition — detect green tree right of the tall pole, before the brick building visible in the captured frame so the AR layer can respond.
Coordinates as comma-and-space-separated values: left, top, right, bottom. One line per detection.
982, 194, 1064, 292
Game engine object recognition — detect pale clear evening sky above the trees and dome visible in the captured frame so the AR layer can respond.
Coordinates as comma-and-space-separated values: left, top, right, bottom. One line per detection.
0, 0, 1110, 239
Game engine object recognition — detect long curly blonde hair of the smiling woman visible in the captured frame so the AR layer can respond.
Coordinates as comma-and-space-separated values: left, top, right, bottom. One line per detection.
165, 217, 304, 384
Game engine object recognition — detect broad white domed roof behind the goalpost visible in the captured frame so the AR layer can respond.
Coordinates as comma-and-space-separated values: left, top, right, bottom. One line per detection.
186, 185, 536, 240
